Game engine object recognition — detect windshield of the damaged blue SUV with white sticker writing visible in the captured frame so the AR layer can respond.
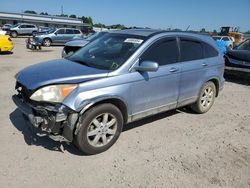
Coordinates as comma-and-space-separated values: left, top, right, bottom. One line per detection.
67, 33, 144, 70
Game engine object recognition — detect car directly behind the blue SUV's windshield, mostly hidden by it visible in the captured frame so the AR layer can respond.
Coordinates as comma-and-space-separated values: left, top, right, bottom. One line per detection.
62, 32, 107, 58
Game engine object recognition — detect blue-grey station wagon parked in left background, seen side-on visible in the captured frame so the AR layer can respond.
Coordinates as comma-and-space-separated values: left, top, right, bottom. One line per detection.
34, 28, 82, 47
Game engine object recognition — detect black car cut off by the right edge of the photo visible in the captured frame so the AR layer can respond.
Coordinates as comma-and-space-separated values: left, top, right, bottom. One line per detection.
225, 39, 250, 73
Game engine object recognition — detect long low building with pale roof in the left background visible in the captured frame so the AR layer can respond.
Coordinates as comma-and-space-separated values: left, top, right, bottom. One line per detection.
0, 12, 90, 31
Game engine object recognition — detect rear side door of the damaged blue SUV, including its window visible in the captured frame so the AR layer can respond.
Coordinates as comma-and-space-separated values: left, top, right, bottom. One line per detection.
178, 37, 209, 106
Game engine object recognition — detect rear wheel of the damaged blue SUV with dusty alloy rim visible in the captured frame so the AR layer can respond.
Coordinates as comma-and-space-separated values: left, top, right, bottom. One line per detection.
191, 81, 216, 114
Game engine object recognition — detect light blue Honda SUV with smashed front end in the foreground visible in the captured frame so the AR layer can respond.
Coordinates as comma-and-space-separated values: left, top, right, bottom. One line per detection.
13, 29, 224, 154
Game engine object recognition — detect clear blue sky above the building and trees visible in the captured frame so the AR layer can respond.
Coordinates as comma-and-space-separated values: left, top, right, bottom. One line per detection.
0, 0, 250, 32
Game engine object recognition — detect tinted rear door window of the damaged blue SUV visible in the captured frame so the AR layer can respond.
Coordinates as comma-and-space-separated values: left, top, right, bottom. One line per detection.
181, 39, 203, 61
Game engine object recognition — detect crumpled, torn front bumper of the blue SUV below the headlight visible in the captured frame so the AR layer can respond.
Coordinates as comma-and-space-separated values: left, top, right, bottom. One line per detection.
12, 95, 78, 142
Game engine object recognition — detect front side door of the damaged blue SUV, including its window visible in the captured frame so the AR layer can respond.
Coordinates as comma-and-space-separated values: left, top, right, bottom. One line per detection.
130, 37, 181, 115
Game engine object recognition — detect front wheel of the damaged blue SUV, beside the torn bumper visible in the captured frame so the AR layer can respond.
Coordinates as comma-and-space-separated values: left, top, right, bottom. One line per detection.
75, 103, 123, 155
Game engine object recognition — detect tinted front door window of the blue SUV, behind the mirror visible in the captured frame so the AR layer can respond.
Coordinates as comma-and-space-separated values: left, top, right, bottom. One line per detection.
141, 39, 178, 66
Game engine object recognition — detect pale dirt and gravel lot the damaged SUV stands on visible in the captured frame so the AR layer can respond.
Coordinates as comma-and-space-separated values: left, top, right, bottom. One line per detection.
0, 38, 250, 188
